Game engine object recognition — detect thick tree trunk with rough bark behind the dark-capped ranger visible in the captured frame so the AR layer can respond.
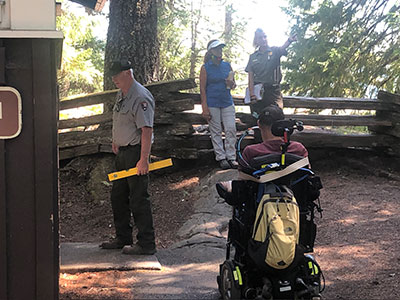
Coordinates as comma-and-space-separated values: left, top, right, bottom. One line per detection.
104, 0, 159, 90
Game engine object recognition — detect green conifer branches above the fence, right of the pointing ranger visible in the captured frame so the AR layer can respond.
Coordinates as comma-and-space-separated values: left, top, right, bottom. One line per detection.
283, 0, 400, 97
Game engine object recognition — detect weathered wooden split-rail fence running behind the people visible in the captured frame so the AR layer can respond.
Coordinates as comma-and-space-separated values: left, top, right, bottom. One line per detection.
59, 79, 400, 159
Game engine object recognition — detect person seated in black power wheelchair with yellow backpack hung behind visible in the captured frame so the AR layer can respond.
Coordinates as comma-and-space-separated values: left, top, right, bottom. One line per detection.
216, 105, 324, 299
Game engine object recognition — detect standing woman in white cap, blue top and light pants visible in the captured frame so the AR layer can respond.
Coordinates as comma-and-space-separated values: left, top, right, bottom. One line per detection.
200, 40, 238, 169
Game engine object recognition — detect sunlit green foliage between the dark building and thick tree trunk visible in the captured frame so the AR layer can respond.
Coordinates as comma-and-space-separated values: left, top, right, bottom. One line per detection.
57, 2, 105, 98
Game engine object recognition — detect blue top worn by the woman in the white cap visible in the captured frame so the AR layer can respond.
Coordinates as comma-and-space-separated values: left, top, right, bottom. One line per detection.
204, 60, 233, 108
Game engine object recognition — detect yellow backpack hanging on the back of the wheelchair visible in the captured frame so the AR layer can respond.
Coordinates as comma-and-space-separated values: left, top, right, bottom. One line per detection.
248, 183, 300, 269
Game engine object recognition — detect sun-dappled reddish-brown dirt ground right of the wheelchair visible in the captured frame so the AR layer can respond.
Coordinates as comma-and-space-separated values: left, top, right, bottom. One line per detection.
315, 171, 400, 299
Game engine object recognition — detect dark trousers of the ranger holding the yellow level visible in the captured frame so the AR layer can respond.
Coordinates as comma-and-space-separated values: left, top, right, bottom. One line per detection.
111, 145, 155, 249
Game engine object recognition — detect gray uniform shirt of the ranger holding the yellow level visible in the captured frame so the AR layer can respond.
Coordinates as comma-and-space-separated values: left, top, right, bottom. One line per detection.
112, 80, 154, 146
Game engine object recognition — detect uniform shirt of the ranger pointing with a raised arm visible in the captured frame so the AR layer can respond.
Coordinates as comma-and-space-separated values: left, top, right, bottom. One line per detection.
245, 47, 287, 86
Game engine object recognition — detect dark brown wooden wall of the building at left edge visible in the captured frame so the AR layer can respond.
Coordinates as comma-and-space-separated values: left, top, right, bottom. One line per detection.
0, 38, 61, 300
